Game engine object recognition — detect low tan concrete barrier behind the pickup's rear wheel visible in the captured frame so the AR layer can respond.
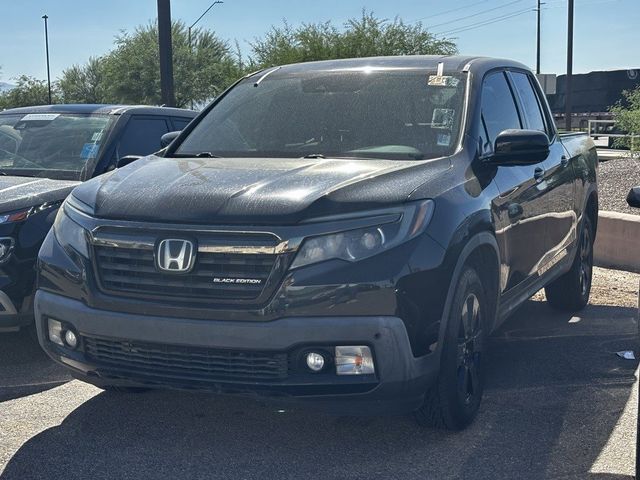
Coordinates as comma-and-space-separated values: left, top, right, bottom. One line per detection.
593, 211, 640, 273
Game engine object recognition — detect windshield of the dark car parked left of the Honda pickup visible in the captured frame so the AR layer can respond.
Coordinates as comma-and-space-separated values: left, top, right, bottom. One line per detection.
0, 113, 112, 180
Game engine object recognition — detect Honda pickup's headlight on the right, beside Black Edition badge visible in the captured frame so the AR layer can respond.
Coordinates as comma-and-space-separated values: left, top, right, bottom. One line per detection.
291, 200, 433, 268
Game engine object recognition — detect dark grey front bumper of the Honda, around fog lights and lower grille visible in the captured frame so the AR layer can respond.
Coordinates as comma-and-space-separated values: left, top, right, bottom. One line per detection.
35, 290, 439, 414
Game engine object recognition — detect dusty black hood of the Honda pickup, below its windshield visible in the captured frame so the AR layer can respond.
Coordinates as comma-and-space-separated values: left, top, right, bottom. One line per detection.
73, 156, 450, 225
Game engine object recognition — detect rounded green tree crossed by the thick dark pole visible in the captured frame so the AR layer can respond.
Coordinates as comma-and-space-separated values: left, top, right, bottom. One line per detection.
101, 22, 239, 107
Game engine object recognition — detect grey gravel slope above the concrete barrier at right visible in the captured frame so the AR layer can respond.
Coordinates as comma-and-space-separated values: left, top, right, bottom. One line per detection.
598, 158, 640, 215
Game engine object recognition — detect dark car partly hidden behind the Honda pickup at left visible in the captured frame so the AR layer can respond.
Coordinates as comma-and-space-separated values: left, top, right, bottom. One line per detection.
0, 105, 196, 331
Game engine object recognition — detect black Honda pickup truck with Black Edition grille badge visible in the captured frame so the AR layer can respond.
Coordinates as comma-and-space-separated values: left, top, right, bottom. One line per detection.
35, 56, 598, 429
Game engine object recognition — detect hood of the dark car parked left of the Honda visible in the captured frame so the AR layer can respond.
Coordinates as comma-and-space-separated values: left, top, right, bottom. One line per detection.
0, 176, 80, 213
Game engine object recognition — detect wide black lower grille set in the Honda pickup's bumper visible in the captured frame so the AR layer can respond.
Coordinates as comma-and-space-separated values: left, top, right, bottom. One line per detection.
83, 337, 288, 385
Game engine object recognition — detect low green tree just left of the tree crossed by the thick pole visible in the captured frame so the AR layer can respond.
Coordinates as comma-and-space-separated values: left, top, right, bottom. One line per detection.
58, 57, 108, 103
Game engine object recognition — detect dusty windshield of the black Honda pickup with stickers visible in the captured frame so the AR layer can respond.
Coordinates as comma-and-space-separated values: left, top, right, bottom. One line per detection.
176, 69, 465, 160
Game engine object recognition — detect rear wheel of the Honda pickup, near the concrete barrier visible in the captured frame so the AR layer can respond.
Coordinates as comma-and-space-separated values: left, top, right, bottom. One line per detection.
544, 217, 593, 312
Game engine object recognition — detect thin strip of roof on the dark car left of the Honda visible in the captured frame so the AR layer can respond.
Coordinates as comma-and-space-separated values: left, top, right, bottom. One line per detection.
0, 104, 197, 117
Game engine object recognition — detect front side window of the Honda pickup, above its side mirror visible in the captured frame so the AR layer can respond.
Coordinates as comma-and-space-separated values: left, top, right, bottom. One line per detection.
480, 72, 522, 153
